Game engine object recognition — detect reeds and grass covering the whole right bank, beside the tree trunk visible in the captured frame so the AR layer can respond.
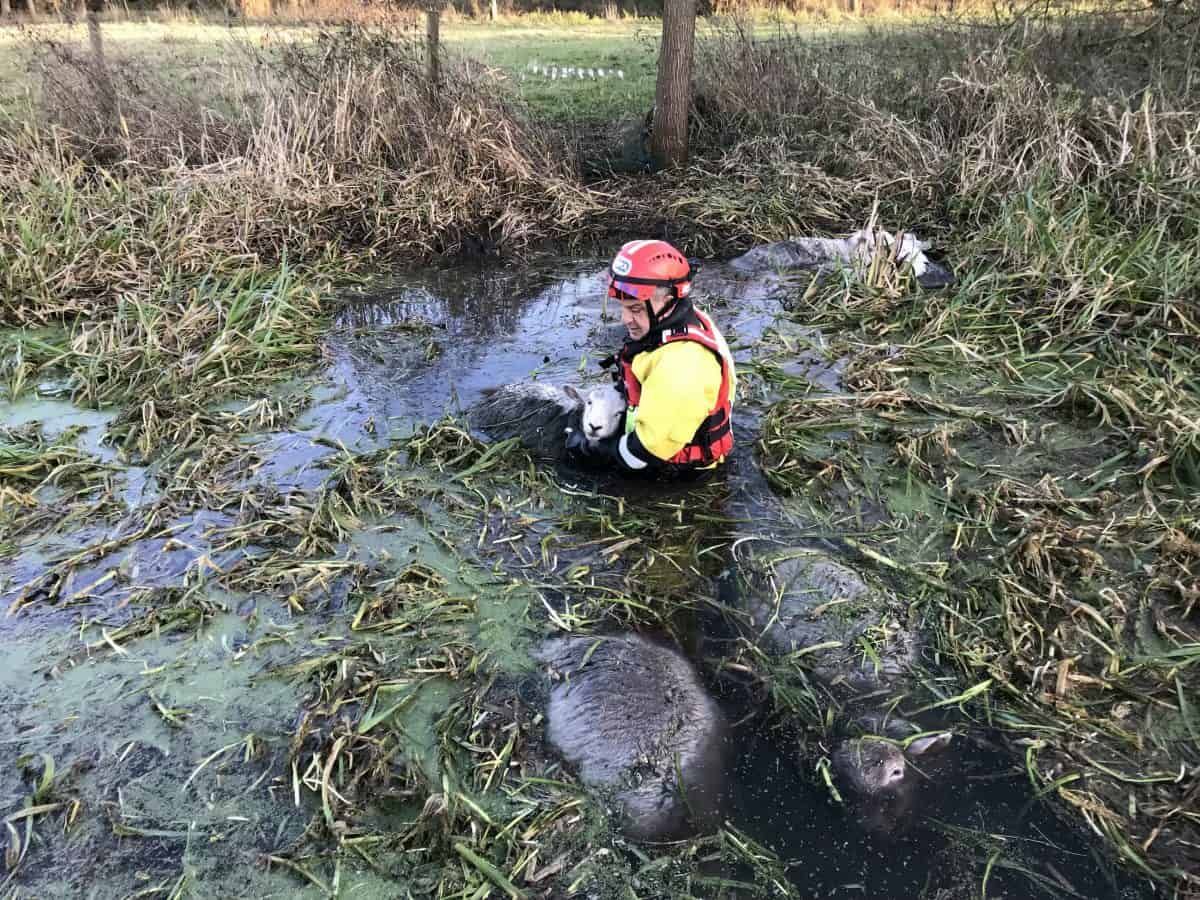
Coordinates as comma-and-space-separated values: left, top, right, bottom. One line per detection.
674, 15, 1200, 896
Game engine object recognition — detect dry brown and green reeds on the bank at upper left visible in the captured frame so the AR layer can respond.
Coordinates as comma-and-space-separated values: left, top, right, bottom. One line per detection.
0, 28, 596, 452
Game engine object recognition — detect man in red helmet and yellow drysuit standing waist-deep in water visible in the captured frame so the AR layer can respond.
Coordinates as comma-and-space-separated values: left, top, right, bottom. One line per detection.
568, 240, 736, 476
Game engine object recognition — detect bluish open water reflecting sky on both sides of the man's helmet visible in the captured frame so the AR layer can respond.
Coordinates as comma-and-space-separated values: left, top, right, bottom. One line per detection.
317, 259, 820, 453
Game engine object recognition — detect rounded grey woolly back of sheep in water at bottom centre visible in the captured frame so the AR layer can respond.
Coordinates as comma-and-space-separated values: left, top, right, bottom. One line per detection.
535, 635, 727, 840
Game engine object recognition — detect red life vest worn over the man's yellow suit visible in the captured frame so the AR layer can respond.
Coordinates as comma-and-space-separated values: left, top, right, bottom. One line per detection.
618, 310, 733, 467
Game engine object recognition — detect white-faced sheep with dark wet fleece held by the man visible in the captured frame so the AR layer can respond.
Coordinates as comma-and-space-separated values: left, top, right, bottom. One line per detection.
467, 382, 625, 458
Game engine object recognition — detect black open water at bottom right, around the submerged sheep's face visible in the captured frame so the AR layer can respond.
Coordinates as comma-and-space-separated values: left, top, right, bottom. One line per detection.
715, 724, 1137, 899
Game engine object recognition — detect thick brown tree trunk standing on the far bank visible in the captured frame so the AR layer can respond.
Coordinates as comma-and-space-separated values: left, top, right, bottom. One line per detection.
650, 0, 696, 168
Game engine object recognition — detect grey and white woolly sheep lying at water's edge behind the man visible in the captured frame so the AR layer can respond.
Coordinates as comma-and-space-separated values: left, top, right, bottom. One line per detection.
732, 229, 954, 288
